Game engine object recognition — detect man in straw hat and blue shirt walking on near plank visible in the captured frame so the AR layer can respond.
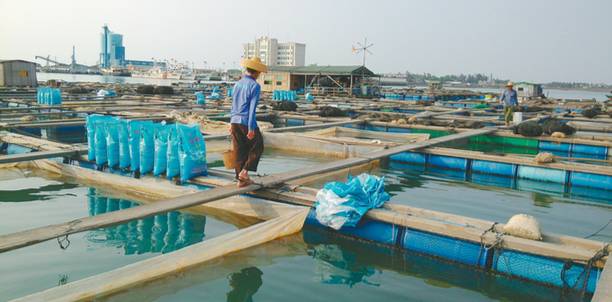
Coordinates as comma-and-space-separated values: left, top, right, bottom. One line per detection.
230, 58, 268, 188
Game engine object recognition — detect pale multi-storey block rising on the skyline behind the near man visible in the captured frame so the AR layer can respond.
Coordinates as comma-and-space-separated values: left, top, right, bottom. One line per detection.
242, 37, 306, 66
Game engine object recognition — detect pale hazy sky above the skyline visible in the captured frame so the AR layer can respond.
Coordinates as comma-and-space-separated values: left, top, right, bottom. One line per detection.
0, 0, 612, 83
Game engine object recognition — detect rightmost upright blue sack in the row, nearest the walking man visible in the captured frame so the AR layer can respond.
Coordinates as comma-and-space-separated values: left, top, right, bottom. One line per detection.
176, 124, 208, 182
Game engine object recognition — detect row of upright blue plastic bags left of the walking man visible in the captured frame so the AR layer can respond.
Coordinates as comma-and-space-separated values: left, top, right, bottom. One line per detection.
86, 114, 208, 182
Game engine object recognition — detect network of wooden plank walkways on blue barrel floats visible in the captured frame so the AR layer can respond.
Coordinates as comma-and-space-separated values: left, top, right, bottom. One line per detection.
0, 83, 612, 301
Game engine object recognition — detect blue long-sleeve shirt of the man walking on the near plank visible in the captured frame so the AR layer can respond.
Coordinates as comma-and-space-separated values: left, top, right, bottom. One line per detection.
230, 75, 261, 131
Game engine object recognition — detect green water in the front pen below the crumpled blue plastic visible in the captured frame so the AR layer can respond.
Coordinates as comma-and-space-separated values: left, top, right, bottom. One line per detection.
109, 227, 571, 302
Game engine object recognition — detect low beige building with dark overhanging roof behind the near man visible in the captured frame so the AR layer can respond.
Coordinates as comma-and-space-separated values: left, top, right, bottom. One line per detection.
257, 65, 376, 95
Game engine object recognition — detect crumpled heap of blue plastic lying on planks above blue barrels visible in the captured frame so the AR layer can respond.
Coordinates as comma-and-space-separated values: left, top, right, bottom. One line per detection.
315, 173, 390, 230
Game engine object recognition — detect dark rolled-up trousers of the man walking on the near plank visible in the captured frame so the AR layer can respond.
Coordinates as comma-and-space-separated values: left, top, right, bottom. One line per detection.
231, 124, 263, 178
